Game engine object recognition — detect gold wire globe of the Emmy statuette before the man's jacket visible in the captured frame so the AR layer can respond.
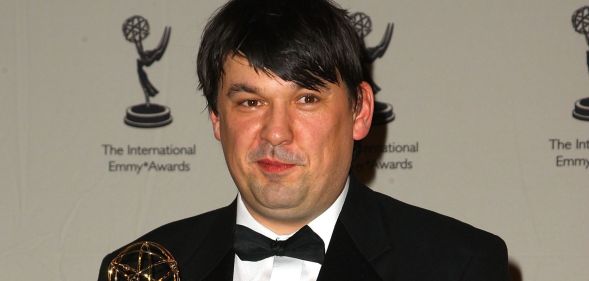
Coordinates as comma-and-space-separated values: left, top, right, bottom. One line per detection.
108, 241, 180, 281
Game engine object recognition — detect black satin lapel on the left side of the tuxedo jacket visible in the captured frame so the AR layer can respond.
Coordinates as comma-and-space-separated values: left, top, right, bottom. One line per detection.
179, 201, 237, 281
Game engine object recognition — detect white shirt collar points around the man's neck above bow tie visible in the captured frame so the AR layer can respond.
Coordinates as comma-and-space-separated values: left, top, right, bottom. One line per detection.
236, 177, 350, 251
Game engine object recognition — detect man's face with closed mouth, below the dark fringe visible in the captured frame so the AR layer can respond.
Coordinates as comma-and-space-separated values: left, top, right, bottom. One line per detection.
210, 56, 373, 233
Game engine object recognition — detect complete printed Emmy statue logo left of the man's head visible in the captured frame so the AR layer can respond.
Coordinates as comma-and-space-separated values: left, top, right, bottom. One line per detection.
123, 16, 172, 128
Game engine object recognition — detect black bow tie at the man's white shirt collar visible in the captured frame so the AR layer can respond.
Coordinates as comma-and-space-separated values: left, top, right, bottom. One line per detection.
233, 224, 325, 264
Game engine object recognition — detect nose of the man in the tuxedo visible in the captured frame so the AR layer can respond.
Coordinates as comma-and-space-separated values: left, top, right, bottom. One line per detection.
261, 105, 293, 146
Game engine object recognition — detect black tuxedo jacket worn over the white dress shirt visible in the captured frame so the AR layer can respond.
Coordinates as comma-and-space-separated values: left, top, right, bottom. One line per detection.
98, 179, 508, 281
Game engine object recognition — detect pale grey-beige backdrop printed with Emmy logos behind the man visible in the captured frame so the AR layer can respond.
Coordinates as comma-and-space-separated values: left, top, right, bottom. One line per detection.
0, 0, 589, 281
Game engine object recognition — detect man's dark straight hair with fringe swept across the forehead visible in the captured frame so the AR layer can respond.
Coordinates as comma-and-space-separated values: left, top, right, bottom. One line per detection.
197, 0, 372, 113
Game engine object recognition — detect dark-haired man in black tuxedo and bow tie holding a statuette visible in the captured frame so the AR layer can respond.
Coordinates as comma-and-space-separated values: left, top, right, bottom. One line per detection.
99, 0, 507, 281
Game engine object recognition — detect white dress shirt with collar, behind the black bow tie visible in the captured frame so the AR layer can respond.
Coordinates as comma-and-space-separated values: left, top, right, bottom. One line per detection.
233, 179, 349, 281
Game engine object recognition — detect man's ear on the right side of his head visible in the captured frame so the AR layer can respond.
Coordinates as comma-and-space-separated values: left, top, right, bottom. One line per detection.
353, 81, 374, 141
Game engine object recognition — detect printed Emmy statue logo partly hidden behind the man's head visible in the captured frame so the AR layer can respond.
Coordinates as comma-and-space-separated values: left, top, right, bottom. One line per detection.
349, 12, 395, 125
